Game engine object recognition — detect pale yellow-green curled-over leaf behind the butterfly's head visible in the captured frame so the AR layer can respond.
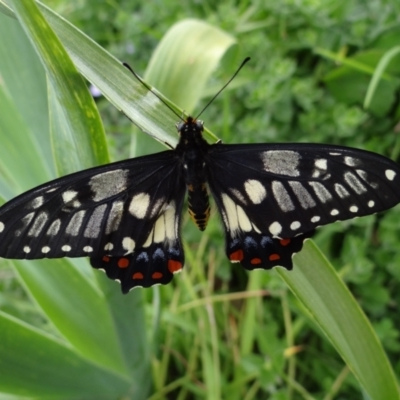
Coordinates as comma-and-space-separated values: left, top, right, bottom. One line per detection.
145, 19, 236, 113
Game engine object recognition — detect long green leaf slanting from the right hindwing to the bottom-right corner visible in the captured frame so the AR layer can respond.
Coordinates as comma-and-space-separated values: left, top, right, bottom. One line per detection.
276, 241, 400, 400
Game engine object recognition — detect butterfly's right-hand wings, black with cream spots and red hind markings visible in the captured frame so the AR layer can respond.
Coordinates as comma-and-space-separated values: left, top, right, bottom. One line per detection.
207, 144, 400, 269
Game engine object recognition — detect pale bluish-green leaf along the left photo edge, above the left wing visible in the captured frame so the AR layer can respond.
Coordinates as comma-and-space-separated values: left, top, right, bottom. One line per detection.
0, 14, 54, 198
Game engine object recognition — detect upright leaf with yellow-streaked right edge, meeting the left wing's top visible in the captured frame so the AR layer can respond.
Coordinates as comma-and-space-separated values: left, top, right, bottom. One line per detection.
14, 0, 109, 174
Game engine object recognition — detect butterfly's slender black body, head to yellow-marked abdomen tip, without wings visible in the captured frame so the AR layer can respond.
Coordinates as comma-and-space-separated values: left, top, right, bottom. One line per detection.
176, 117, 210, 231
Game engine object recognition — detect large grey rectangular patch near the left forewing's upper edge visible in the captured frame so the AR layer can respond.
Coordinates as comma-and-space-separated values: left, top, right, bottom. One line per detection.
89, 169, 129, 201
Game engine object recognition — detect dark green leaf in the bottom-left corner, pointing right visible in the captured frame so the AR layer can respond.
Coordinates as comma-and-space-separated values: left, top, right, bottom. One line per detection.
0, 312, 129, 400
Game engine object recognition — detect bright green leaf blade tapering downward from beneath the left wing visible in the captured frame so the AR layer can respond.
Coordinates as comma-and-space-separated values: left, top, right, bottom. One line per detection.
14, 259, 126, 373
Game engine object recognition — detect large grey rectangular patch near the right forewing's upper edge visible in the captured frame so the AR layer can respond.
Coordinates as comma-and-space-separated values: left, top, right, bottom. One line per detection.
261, 150, 300, 176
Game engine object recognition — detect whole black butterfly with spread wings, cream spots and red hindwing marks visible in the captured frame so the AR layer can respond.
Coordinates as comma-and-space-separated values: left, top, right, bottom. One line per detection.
0, 111, 400, 293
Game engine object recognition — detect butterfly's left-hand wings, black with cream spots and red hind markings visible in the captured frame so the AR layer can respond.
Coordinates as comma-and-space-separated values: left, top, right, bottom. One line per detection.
0, 151, 185, 292
